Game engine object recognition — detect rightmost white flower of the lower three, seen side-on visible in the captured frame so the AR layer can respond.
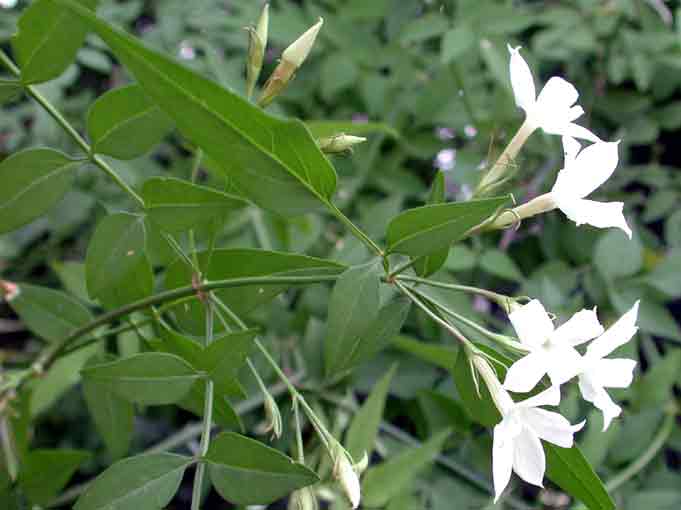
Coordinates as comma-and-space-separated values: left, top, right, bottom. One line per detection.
579, 301, 639, 430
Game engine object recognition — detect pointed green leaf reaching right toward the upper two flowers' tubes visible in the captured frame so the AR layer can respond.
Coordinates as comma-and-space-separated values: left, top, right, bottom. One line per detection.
387, 197, 508, 257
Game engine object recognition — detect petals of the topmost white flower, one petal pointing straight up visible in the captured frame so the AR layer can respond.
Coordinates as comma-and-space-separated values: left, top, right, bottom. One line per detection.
508, 46, 599, 142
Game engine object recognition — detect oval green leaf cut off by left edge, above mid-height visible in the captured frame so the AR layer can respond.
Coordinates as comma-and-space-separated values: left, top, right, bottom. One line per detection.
0, 148, 81, 234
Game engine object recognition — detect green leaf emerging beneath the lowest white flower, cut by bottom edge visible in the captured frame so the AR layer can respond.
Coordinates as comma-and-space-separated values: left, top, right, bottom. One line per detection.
542, 441, 615, 510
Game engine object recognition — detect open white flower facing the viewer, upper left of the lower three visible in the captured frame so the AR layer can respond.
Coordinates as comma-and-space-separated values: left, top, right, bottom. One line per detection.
504, 299, 603, 392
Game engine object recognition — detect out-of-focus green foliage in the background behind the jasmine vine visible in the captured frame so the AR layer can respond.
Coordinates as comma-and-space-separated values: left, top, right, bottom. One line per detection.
0, 0, 681, 510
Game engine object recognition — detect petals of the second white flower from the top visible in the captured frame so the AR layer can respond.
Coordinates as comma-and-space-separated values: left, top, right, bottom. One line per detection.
551, 136, 631, 239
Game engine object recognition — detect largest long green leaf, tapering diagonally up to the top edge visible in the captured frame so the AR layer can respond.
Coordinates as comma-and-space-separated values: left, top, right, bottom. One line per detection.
59, 0, 336, 216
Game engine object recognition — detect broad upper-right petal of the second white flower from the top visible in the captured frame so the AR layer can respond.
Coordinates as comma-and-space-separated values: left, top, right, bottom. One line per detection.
553, 142, 619, 198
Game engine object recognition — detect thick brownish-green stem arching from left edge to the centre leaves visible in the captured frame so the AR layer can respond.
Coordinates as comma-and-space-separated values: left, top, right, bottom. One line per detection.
5, 275, 338, 387
